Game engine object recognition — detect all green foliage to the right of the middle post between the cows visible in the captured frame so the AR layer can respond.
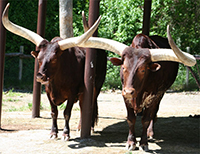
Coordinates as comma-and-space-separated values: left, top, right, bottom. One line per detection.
99, 0, 200, 90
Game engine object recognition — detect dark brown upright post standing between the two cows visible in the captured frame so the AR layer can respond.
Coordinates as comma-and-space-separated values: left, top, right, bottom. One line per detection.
81, 0, 100, 138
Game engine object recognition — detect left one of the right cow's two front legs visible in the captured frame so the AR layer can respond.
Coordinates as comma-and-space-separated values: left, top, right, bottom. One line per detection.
126, 104, 137, 150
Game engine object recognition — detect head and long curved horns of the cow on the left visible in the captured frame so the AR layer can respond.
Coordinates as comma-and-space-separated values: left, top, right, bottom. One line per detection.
2, 4, 101, 84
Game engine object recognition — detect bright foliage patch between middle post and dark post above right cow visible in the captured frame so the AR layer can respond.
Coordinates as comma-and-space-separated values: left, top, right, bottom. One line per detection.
99, 0, 143, 45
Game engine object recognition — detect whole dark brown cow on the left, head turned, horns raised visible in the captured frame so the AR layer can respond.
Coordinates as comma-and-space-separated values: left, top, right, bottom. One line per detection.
2, 4, 107, 140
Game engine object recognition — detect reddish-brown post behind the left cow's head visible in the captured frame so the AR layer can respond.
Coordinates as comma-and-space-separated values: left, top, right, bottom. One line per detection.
32, 0, 47, 118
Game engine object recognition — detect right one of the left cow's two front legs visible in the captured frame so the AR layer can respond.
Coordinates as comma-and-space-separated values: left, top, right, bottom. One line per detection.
62, 100, 74, 141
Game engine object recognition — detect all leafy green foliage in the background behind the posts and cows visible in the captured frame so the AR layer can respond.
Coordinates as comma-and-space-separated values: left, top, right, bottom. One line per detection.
4, 0, 200, 90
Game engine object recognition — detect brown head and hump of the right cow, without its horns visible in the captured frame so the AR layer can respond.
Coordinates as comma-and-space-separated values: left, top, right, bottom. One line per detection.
115, 34, 161, 104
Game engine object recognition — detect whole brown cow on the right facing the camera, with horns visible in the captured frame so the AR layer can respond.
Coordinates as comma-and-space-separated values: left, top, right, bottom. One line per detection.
65, 26, 196, 151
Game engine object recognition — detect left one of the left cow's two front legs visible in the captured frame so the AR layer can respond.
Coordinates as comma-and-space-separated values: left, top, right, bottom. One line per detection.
50, 103, 58, 139
